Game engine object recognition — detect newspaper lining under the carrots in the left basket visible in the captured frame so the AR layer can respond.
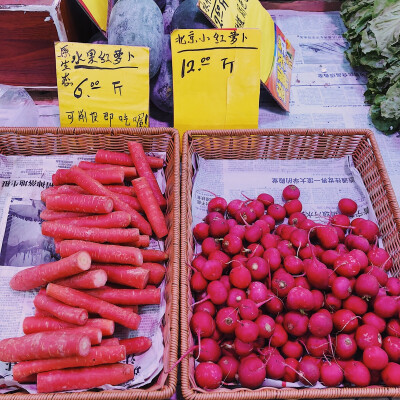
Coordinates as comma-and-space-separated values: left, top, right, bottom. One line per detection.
0, 153, 166, 393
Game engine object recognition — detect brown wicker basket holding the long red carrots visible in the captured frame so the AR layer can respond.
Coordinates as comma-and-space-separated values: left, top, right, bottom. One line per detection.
0, 128, 180, 400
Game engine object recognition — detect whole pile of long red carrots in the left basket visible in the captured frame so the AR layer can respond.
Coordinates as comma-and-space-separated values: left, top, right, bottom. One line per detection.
0, 142, 168, 393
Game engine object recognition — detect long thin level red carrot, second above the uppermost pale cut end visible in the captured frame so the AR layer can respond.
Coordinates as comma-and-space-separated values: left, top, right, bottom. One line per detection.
42, 221, 139, 244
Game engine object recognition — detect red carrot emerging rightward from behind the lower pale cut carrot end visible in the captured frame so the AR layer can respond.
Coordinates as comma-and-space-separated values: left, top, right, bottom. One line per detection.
91, 264, 150, 289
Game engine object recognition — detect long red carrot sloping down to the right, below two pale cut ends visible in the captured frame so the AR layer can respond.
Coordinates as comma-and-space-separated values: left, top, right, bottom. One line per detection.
46, 283, 140, 329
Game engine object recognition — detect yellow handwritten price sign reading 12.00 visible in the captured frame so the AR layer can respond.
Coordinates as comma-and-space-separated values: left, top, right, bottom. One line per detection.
171, 29, 261, 134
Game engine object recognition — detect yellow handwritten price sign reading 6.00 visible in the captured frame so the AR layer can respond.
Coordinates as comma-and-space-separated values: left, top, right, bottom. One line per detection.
55, 42, 149, 128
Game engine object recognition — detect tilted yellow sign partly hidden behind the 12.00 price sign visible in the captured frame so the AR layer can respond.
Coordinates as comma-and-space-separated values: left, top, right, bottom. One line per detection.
198, 0, 295, 111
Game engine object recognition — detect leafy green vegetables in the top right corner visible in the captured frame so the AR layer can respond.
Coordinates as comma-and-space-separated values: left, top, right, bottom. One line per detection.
341, 0, 400, 134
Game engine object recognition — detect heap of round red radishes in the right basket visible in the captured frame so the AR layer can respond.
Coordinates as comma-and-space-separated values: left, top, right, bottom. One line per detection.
188, 185, 400, 389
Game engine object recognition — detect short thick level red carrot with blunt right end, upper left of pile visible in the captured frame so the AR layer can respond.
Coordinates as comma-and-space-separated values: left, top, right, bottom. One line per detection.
46, 194, 114, 214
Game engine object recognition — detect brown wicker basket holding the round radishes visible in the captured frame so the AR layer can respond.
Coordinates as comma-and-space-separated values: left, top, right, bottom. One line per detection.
181, 129, 400, 400
